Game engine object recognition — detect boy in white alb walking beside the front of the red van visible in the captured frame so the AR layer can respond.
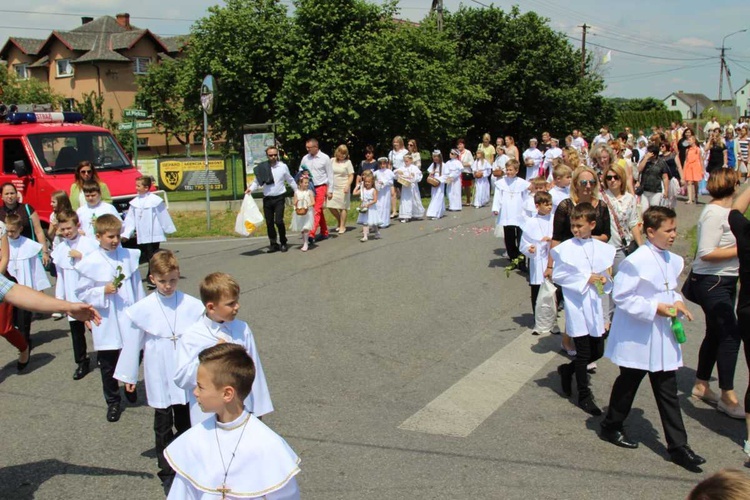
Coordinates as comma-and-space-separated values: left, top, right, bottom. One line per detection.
122, 175, 177, 270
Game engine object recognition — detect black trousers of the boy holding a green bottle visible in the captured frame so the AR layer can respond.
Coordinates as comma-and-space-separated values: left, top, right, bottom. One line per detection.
602, 366, 687, 451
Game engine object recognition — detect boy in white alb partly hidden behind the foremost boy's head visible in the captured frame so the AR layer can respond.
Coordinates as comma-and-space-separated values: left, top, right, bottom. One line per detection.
174, 273, 273, 426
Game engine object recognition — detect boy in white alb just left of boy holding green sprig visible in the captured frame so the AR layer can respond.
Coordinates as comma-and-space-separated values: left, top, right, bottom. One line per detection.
52, 210, 99, 380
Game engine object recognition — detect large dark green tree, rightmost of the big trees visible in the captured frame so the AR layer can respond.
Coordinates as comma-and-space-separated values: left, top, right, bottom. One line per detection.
445, 7, 614, 140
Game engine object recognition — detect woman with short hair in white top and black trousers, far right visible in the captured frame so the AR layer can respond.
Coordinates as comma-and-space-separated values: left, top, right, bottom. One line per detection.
685, 168, 745, 419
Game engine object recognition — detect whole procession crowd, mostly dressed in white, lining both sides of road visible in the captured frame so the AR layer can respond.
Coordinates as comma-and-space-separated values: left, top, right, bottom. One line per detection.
7, 123, 750, 492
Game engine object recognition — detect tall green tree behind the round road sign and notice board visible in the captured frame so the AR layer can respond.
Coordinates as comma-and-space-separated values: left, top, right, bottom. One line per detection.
182, 0, 293, 147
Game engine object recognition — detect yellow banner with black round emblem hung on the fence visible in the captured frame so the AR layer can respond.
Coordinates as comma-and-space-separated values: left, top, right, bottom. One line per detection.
159, 158, 227, 191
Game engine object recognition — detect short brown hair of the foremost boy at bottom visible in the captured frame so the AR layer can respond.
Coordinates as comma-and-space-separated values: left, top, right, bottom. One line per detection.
198, 342, 255, 401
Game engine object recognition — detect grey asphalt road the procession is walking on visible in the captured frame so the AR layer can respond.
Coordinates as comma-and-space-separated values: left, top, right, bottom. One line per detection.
0, 201, 748, 500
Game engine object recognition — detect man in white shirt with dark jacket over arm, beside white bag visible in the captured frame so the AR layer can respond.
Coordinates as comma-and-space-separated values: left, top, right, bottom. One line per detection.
245, 146, 297, 253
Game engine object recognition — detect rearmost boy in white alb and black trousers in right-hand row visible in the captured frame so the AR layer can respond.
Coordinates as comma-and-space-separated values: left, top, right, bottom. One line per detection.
492, 158, 530, 268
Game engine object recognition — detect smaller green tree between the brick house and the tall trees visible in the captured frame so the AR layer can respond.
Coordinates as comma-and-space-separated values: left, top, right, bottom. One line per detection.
135, 59, 203, 149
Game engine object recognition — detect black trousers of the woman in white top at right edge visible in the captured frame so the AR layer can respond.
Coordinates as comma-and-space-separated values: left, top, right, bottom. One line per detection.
691, 274, 742, 391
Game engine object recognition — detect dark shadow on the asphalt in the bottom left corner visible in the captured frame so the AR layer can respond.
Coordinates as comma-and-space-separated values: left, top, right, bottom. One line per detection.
0, 459, 154, 500
